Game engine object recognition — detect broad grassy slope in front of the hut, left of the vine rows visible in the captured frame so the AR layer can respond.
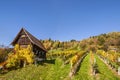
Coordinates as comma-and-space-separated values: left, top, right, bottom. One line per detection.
2, 59, 70, 80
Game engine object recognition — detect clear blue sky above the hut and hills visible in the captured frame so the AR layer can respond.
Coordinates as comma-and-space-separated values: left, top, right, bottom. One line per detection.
0, 0, 120, 45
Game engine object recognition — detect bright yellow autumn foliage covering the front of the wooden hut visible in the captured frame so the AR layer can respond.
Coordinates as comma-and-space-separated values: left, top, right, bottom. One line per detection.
6, 44, 34, 68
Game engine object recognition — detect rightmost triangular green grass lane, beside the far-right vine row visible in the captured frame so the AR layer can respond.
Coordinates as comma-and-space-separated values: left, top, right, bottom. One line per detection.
95, 56, 120, 80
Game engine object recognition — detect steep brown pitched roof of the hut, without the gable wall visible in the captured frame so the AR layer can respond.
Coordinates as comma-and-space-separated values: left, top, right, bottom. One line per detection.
11, 28, 47, 51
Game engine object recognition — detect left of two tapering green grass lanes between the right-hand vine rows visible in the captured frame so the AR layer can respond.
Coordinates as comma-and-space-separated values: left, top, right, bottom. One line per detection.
73, 54, 93, 80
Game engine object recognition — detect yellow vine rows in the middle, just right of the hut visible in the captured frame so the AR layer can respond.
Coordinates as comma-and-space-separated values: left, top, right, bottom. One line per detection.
47, 50, 86, 66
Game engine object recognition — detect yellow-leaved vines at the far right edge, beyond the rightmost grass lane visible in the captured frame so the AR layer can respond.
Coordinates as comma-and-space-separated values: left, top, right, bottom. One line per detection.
96, 50, 120, 71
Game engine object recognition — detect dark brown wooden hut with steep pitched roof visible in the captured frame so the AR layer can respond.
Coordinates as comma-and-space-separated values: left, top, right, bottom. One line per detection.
11, 28, 47, 61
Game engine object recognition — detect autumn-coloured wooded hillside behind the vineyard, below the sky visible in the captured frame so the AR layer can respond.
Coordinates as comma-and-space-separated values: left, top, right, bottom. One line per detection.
41, 32, 120, 52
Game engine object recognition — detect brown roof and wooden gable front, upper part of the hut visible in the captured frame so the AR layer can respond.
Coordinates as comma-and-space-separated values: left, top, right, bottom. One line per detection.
11, 28, 46, 52
